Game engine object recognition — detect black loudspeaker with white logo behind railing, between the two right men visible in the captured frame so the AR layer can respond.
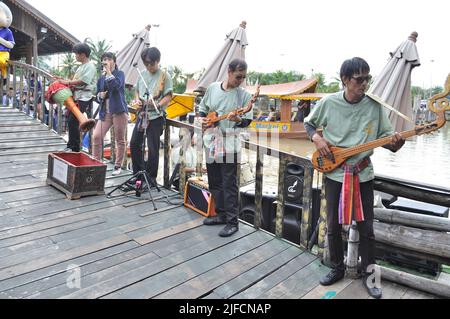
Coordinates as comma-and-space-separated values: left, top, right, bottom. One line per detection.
284, 163, 305, 205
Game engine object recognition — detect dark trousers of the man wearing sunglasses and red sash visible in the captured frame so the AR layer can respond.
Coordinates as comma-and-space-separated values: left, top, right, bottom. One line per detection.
326, 179, 375, 272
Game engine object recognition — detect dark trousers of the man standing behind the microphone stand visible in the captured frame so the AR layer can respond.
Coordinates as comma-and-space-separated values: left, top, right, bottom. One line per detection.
130, 117, 165, 179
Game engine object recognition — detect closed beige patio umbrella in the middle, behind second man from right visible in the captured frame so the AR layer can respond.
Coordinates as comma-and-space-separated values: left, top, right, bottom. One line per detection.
195, 21, 248, 92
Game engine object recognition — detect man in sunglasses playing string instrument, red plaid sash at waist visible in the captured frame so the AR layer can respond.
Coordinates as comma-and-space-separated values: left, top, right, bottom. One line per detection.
304, 58, 405, 298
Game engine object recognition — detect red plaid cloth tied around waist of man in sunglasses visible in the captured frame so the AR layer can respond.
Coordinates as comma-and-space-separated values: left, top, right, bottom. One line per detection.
339, 157, 370, 225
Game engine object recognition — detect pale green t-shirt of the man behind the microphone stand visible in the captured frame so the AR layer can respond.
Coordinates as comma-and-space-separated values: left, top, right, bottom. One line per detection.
136, 69, 173, 120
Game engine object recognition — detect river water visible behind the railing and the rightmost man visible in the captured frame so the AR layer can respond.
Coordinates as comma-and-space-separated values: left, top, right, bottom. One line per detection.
244, 122, 450, 189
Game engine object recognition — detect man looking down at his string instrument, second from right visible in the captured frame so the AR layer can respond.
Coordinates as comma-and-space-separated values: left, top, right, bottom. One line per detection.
200, 59, 253, 237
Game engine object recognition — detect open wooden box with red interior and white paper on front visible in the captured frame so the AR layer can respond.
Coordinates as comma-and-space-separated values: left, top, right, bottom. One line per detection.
47, 152, 107, 199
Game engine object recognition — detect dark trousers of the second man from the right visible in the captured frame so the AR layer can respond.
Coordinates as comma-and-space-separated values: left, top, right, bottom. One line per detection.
206, 154, 239, 226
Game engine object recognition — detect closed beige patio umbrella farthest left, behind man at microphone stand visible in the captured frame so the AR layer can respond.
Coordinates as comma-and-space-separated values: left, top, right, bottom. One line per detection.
117, 25, 151, 86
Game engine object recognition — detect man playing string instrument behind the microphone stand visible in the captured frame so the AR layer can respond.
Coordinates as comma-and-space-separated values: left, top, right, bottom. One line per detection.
130, 47, 173, 183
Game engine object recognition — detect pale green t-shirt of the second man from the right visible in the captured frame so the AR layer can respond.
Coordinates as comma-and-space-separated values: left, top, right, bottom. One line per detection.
199, 82, 253, 154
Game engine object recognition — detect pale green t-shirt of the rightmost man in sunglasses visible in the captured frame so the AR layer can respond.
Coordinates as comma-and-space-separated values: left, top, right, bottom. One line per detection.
305, 92, 394, 183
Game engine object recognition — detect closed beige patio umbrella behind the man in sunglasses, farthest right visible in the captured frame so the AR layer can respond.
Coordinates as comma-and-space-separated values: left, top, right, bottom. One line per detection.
368, 32, 420, 132
